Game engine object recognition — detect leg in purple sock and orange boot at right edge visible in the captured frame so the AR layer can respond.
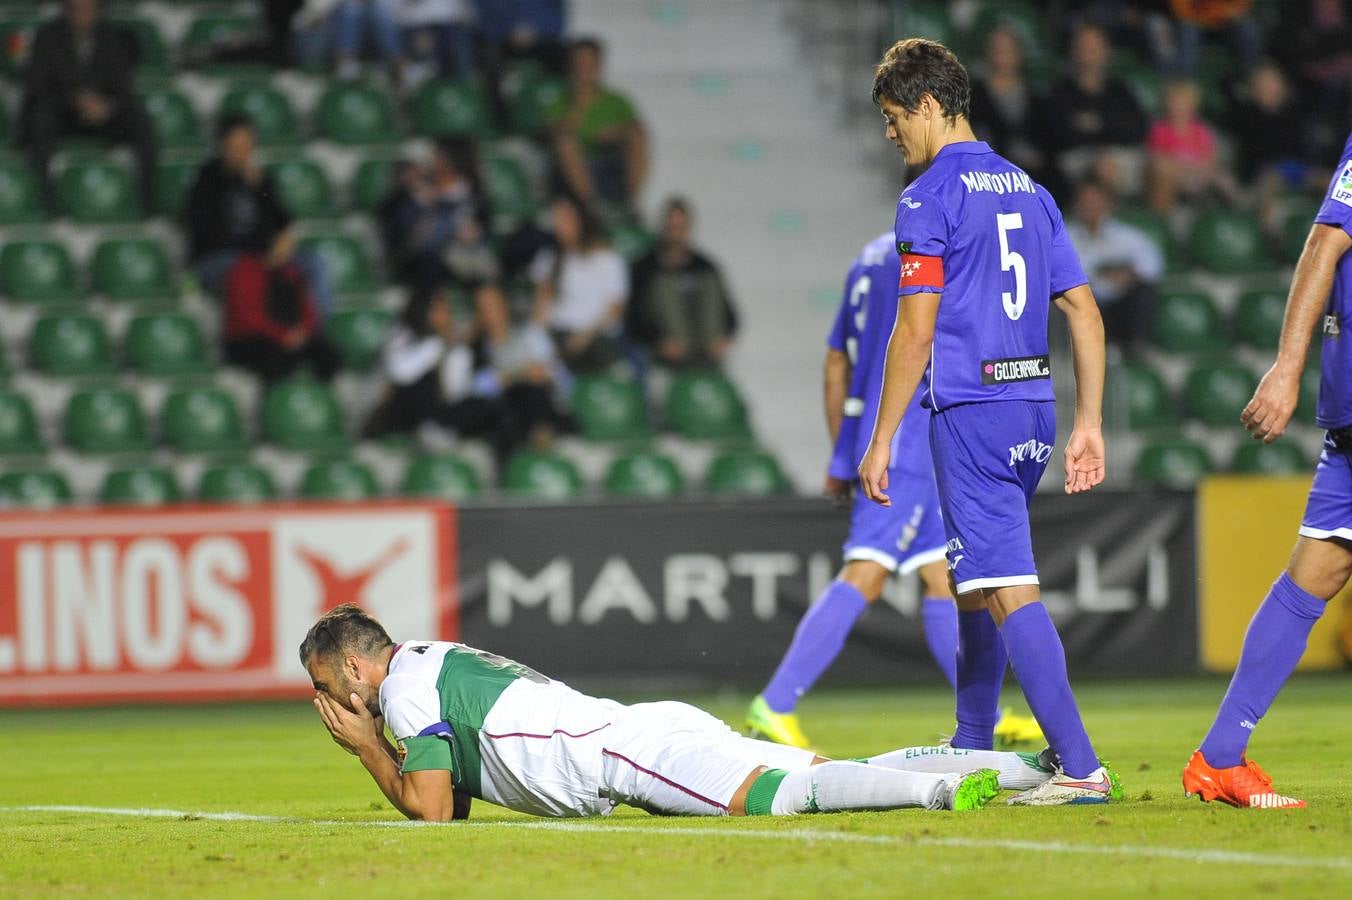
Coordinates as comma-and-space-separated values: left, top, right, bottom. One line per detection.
1183, 441, 1352, 809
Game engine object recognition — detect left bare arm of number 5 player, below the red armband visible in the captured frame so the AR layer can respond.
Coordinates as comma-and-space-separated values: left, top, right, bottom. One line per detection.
859, 293, 940, 507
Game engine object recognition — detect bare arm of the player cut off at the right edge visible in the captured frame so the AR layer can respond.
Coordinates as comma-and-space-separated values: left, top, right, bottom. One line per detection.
1240, 224, 1352, 443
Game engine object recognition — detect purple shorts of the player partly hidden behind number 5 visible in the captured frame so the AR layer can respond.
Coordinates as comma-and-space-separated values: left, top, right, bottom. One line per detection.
845, 472, 946, 574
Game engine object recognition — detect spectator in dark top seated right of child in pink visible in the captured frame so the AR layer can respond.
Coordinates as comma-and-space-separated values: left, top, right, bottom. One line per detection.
1229, 62, 1322, 232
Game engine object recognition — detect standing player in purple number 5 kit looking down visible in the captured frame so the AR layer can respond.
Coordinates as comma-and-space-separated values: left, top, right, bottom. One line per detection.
859, 38, 1121, 805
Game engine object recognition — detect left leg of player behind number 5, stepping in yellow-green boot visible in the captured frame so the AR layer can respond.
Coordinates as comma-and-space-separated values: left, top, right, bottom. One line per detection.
746, 497, 900, 747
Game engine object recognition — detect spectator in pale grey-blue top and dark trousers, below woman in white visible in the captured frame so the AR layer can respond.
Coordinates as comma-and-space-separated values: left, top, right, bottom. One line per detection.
475, 286, 572, 455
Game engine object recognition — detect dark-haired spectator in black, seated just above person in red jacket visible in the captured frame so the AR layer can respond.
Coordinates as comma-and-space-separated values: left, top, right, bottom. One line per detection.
184, 115, 333, 314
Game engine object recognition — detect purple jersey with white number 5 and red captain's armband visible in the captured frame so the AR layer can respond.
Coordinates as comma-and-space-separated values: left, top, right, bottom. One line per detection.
894, 141, 1088, 409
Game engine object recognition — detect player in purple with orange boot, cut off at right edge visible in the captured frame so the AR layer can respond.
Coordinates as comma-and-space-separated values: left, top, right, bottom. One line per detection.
1183, 136, 1352, 809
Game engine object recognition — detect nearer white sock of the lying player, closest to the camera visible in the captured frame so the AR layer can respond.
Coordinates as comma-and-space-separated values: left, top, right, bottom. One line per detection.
771, 762, 944, 816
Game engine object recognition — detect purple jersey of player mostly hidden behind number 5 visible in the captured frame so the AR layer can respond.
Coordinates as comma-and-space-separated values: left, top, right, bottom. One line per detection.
826, 232, 934, 481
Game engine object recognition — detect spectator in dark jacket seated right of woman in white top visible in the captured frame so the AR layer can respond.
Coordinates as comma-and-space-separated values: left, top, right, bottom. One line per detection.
626, 197, 737, 368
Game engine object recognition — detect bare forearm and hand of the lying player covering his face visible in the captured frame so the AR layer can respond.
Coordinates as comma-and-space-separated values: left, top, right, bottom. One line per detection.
315, 693, 454, 822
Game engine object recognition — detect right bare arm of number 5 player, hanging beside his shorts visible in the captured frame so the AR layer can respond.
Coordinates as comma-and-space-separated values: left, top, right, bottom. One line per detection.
1056, 284, 1106, 493
